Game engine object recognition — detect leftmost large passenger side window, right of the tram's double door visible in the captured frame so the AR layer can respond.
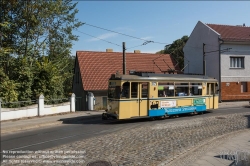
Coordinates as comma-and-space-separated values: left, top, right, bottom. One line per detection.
158, 82, 174, 97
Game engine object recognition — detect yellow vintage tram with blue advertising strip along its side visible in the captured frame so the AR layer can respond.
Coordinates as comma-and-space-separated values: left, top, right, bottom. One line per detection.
102, 72, 218, 119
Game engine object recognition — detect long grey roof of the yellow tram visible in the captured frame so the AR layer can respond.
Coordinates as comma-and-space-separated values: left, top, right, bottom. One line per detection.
110, 73, 217, 82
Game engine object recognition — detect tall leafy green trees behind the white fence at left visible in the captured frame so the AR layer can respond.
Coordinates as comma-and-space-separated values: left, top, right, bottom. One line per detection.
0, 0, 82, 104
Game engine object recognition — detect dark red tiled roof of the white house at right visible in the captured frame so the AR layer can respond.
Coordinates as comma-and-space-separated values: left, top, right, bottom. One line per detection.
207, 24, 250, 42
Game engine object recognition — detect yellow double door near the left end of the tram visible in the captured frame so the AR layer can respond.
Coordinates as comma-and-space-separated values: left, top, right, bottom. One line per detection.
130, 82, 148, 117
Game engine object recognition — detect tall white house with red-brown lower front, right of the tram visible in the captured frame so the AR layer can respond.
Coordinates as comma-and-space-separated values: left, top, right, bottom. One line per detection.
183, 21, 250, 101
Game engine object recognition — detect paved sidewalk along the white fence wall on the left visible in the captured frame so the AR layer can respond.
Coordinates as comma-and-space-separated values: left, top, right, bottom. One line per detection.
1, 110, 104, 134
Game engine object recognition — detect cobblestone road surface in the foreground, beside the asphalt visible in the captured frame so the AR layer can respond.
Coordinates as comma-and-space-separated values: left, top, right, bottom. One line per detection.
3, 113, 250, 166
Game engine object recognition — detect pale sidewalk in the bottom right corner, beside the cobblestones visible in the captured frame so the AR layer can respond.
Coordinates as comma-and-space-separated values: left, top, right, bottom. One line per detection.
191, 129, 250, 166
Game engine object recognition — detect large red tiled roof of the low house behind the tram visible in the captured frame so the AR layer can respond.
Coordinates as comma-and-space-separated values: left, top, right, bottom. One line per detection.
76, 51, 179, 90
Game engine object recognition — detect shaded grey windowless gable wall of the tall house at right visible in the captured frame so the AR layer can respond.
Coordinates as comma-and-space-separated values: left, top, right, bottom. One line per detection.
183, 21, 219, 79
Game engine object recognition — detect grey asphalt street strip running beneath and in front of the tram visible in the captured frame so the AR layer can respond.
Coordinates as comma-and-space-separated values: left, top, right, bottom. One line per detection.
1, 107, 249, 157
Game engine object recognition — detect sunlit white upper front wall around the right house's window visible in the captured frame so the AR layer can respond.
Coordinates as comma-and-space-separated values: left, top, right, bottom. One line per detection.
221, 44, 250, 82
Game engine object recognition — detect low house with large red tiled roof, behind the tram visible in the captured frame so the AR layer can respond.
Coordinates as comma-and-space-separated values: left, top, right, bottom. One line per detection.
72, 49, 179, 111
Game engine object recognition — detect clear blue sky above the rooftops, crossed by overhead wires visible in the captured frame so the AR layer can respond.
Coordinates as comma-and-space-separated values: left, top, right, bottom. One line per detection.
72, 1, 250, 55
